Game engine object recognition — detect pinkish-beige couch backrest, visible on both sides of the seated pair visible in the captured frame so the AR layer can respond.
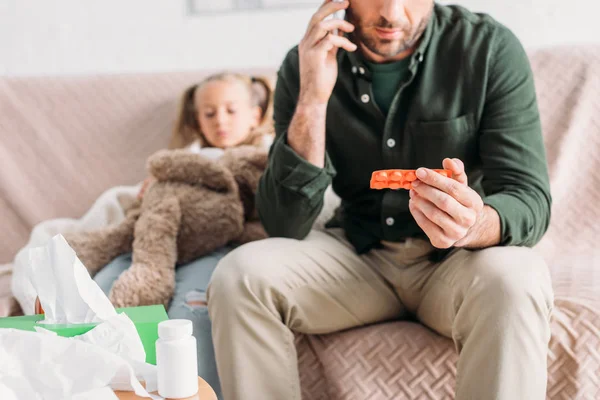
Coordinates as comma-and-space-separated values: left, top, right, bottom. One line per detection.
0, 46, 600, 265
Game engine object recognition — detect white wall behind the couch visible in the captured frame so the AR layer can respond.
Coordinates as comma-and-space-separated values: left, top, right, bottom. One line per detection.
0, 0, 600, 75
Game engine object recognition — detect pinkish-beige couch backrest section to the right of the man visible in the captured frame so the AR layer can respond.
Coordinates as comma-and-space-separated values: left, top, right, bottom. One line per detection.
530, 45, 600, 280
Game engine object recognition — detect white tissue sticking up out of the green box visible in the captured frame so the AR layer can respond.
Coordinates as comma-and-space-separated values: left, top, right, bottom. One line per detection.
27, 235, 117, 324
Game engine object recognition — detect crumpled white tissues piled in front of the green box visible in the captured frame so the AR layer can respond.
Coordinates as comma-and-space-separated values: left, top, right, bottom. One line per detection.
0, 329, 150, 400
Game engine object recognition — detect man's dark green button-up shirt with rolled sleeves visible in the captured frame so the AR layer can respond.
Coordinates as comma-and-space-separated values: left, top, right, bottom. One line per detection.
257, 4, 552, 253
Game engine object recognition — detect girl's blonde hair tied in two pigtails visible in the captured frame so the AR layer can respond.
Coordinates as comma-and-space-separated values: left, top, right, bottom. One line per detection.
169, 72, 273, 149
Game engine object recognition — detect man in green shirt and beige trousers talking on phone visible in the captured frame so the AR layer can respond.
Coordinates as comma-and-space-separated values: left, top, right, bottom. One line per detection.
209, 0, 553, 400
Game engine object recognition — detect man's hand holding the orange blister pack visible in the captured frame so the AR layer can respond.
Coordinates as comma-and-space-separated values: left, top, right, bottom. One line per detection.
409, 158, 488, 248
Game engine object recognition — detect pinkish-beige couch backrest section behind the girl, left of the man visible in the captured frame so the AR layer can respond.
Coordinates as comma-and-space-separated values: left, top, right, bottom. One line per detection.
0, 70, 273, 264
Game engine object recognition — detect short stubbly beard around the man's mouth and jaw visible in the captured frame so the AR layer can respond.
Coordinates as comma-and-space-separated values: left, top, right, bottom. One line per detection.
347, 7, 433, 58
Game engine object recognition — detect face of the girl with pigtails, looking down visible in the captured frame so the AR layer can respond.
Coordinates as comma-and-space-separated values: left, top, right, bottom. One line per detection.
195, 79, 261, 148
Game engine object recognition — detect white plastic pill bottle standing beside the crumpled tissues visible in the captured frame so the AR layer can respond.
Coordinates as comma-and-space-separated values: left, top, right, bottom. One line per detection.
156, 319, 198, 399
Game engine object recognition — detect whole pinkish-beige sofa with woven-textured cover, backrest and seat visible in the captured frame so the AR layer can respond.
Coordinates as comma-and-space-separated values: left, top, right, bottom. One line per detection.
0, 45, 600, 400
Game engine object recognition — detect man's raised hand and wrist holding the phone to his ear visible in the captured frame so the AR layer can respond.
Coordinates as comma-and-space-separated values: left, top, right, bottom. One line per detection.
298, 0, 357, 106
